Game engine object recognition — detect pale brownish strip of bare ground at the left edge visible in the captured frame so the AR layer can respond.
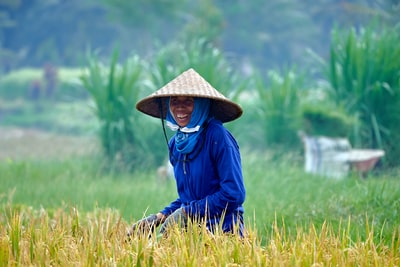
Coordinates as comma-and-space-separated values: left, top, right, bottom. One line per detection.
0, 127, 99, 160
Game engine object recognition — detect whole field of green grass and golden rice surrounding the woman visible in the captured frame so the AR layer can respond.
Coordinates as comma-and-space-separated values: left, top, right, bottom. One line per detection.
0, 151, 400, 266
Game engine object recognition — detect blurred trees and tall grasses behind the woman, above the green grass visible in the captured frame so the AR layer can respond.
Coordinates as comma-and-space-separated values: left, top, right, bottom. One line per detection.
0, 0, 400, 169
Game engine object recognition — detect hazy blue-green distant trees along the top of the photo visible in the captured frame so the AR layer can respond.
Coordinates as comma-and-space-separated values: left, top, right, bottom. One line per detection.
0, 0, 400, 70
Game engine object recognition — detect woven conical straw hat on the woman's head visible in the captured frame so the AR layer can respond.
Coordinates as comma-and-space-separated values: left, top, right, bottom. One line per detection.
136, 69, 243, 122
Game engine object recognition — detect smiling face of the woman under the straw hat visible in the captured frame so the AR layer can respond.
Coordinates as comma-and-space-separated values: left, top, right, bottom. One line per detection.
169, 96, 194, 127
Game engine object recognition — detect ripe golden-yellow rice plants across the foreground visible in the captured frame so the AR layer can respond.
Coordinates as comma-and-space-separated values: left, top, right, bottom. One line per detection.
0, 207, 400, 266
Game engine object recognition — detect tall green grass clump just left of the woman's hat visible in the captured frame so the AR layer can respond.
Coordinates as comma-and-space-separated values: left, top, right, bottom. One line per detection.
81, 50, 163, 170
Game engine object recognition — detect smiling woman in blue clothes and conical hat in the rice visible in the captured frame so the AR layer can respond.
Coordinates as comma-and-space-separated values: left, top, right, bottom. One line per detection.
130, 69, 246, 237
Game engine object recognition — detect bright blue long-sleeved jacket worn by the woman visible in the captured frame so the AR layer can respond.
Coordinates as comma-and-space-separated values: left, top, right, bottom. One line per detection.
161, 119, 246, 231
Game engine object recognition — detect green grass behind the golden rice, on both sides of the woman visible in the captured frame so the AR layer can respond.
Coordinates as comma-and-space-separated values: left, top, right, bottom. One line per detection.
0, 152, 400, 242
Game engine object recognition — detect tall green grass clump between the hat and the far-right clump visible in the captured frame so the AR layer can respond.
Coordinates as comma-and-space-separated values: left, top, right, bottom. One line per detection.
249, 69, 304, 149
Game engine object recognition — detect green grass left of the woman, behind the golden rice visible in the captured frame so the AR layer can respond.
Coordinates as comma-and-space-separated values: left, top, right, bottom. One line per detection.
0, 158, 176, 223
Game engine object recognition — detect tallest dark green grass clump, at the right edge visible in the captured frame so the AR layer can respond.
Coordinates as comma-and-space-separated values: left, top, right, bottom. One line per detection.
328, 22, 400, 166
